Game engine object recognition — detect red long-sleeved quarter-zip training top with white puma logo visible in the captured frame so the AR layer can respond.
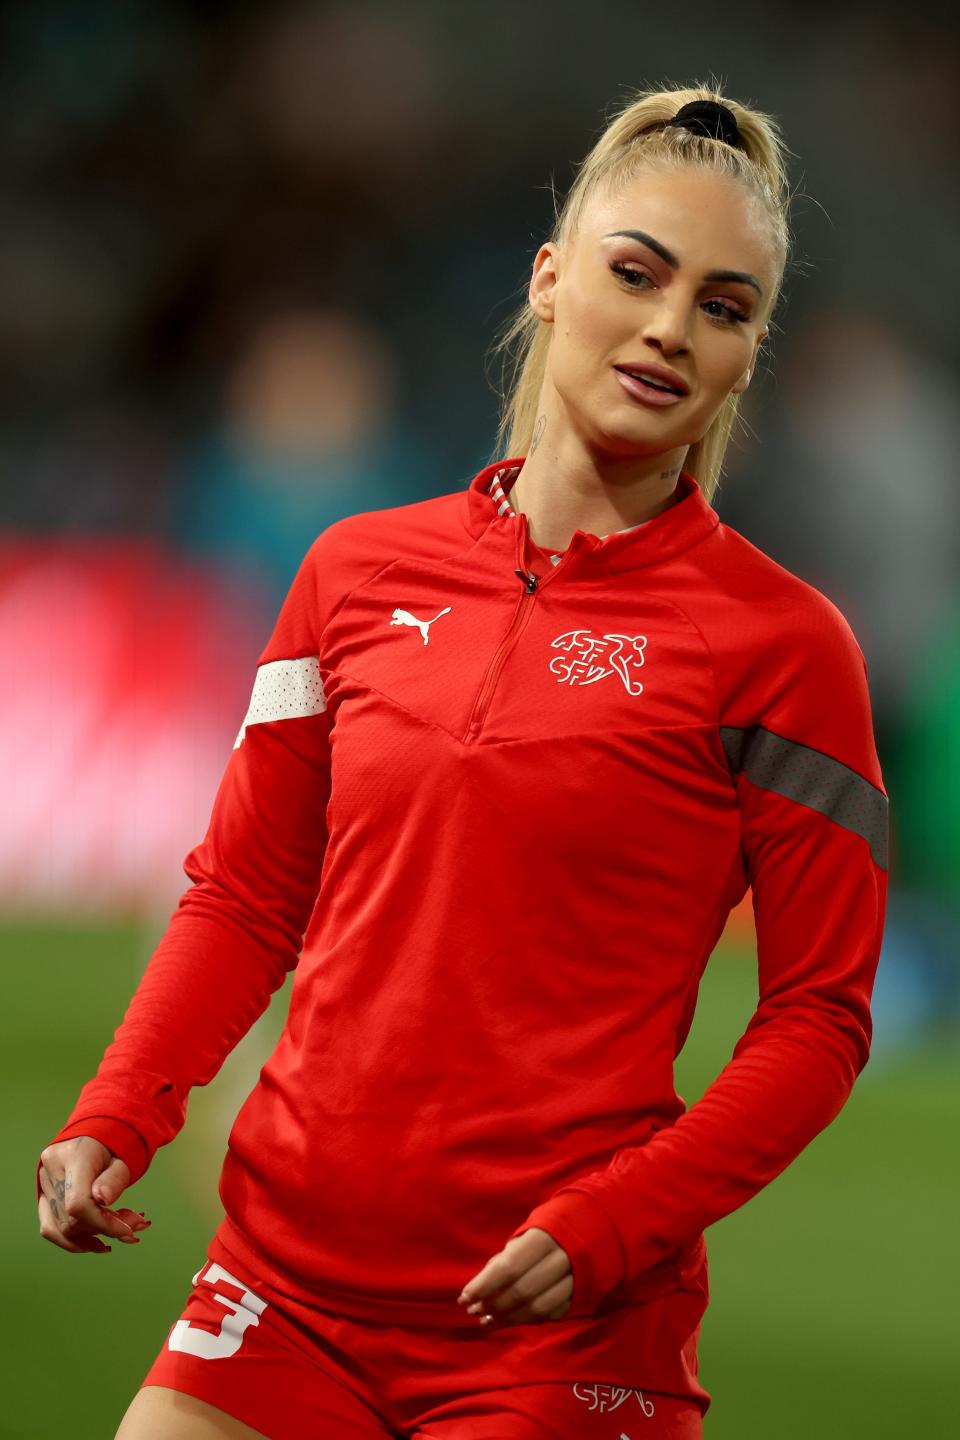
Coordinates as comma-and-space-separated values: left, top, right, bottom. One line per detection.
43, 459, 888, 1400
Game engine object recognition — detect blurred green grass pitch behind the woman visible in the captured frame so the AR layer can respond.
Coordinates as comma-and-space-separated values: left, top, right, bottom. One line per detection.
11, 922, 960, 1440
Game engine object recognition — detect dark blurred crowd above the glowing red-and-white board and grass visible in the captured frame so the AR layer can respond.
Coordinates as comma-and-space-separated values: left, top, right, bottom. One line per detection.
0, 0, 960, 1036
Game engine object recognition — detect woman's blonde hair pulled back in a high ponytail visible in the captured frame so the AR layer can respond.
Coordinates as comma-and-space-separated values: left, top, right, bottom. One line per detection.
489, 85, 792, 501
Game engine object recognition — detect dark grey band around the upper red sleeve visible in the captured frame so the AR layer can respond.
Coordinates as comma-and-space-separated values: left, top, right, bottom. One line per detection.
720, 724, 889, 870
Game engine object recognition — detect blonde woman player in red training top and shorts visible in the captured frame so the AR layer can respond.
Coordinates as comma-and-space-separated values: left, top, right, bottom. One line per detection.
37, 86, 887, 1440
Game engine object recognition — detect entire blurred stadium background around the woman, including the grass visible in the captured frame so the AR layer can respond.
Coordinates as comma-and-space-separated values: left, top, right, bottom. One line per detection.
0, 0, 960, 1440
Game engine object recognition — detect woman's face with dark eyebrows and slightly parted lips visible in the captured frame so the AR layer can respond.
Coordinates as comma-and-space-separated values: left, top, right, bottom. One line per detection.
530, 168, 774, 455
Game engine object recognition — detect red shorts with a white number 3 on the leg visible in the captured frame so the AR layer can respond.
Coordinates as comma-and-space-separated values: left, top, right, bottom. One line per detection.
142, 1251, 702, 1440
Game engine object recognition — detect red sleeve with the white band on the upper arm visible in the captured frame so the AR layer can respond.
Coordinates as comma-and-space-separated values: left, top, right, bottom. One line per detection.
37, 537, 336, 1195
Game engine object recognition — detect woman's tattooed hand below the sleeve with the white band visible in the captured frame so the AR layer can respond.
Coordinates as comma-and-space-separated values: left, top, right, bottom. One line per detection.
37, 1135, 153, 1254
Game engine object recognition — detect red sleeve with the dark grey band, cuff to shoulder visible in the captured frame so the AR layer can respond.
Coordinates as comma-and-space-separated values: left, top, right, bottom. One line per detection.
514, 602, 888, 1313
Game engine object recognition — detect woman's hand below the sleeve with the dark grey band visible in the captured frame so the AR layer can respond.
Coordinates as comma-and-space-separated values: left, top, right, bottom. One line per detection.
458, 1225, 573, 1325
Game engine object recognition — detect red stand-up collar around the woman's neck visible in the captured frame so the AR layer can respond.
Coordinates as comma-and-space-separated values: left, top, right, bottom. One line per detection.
463, 456, 720, 570
